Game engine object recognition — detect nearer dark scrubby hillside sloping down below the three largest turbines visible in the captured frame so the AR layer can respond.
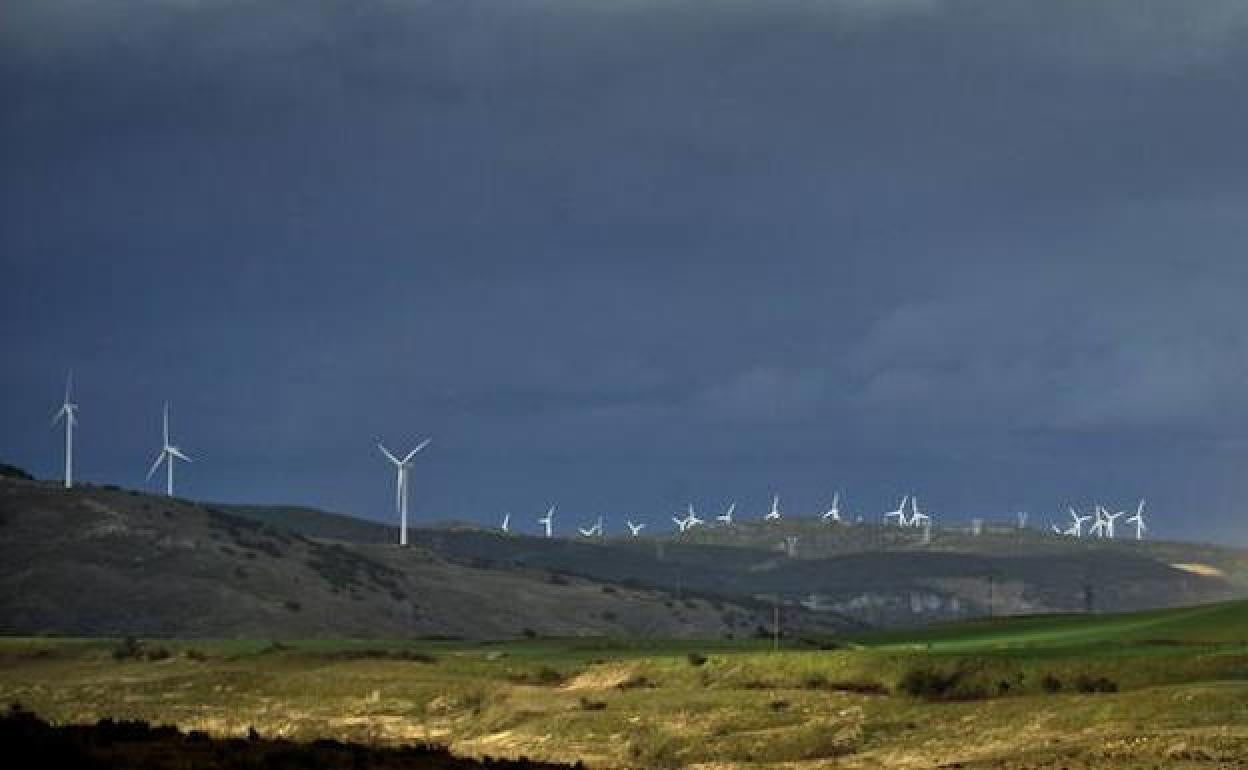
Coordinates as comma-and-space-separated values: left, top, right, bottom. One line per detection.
0, 479, 788, 638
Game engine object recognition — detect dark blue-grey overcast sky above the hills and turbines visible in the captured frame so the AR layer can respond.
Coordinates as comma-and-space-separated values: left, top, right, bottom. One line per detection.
0, 0, 1248, 543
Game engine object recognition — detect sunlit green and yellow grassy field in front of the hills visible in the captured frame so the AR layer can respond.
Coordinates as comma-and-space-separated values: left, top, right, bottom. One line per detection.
0, 603, 1248, 769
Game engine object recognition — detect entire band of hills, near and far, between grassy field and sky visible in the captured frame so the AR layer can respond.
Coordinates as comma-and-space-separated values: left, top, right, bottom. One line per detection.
0, 478, 1248, 639
